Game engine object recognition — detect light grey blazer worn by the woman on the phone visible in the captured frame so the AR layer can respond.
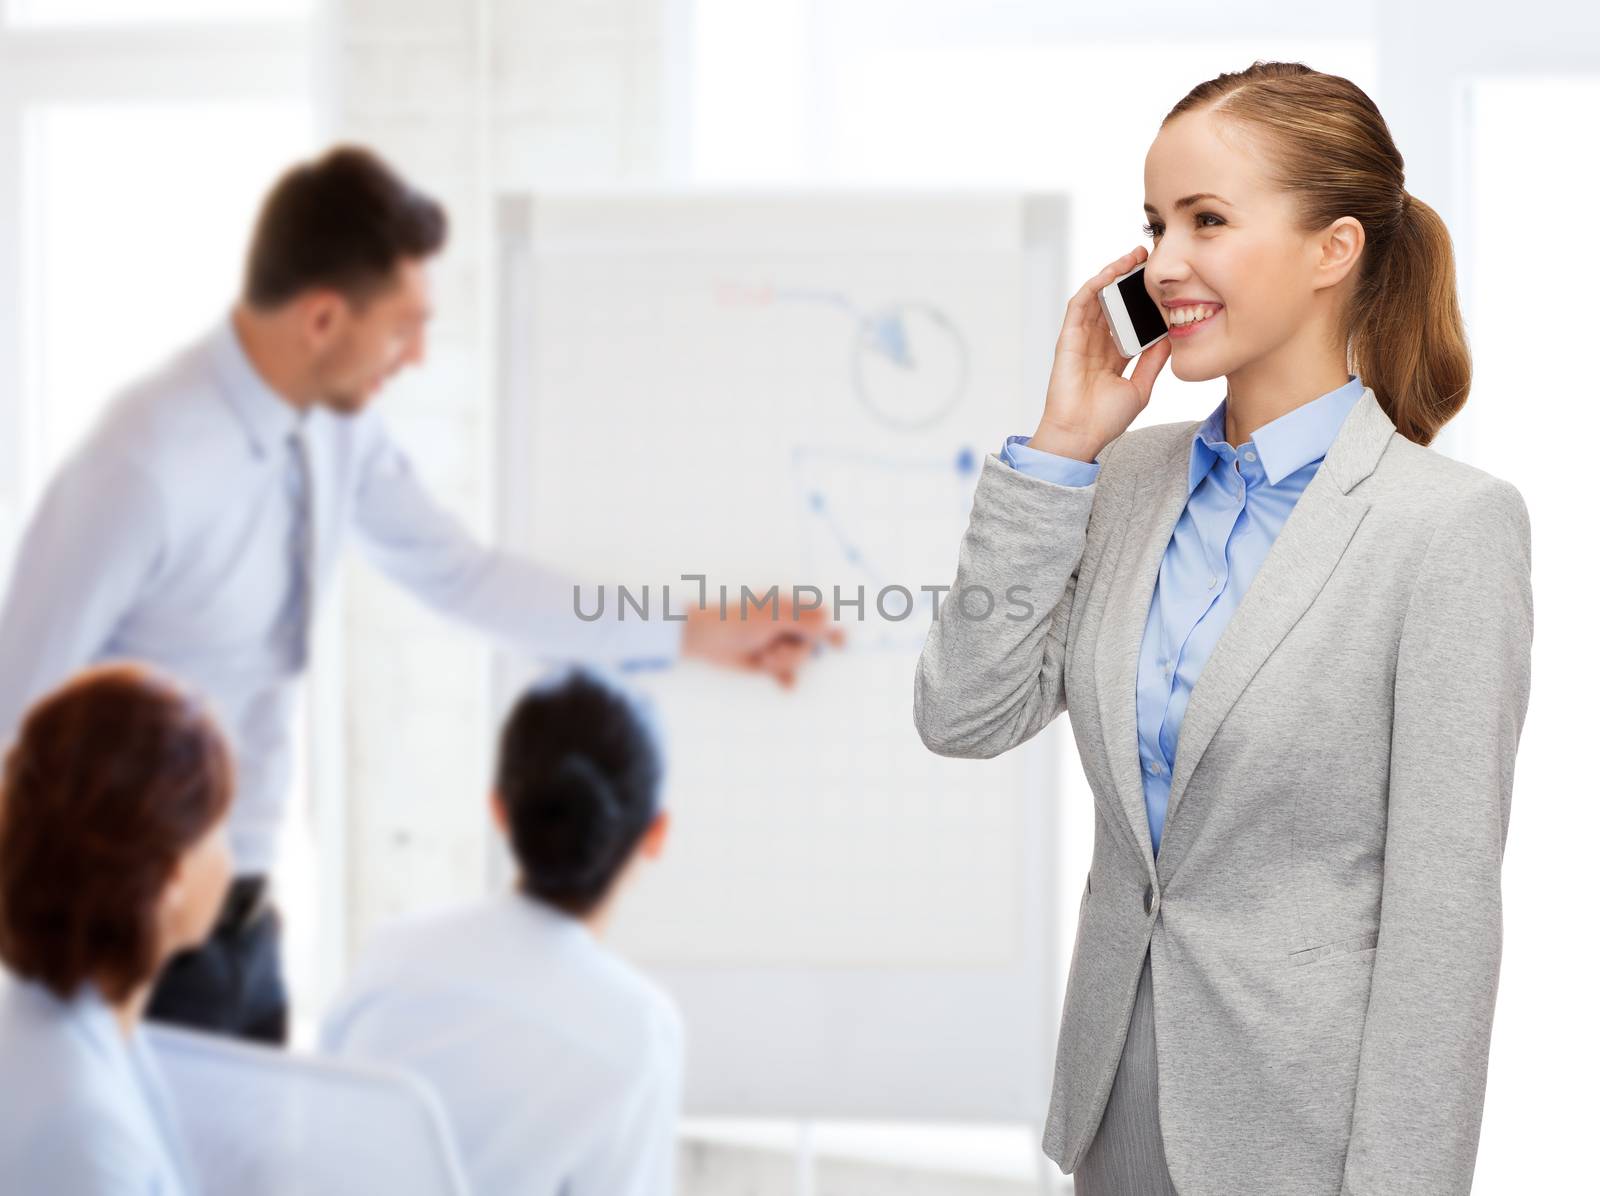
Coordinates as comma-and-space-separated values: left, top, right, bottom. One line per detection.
914, 389, 1533, 1196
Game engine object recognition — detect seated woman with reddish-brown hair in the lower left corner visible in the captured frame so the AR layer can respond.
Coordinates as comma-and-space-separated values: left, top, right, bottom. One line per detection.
0, 665, 234, 1196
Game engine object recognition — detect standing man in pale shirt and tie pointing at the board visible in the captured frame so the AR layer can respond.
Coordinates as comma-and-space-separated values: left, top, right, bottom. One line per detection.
0, 147, 843, 1043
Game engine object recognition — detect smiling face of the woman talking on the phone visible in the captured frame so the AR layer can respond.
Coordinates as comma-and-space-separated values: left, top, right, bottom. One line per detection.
1144, 112, 1336, 382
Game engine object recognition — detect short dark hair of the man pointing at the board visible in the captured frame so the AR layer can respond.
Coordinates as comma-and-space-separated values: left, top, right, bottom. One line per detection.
245, 146, 446, 310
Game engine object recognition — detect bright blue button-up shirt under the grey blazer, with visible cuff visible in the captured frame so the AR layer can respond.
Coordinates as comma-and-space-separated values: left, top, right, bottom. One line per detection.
1000, 374, 1366, 852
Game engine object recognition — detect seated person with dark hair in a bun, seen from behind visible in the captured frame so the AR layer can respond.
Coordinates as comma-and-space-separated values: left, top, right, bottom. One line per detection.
323, 672, 683, 1196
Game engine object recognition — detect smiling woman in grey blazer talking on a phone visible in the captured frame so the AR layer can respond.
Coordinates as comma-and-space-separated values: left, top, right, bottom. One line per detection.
915, 62, 1533, 1196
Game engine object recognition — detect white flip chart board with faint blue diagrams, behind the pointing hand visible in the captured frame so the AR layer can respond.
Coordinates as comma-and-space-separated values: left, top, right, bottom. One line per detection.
498, 193, 1066, 1119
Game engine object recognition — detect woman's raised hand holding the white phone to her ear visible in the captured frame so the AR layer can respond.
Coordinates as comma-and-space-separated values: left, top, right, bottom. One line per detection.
1029, 245, 1173, 460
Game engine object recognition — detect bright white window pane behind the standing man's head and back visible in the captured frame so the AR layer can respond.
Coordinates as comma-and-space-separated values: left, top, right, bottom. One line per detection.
22, 101, 312, 492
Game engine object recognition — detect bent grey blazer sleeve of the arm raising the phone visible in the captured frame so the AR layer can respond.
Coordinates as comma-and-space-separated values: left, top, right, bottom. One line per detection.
912, 441, 1118, 759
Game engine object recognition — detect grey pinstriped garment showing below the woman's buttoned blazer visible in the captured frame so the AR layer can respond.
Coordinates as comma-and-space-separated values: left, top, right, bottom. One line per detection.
1072, 948, 1178, 1196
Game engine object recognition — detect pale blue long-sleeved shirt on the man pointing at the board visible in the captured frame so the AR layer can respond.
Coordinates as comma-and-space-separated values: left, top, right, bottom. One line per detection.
0, 318, 683, 873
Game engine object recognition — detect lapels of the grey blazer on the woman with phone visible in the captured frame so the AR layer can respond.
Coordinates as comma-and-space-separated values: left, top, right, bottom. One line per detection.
1094, 387, 1395, 884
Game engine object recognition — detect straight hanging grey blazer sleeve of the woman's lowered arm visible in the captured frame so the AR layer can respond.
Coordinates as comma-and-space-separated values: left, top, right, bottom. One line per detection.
1342, 478, 1533, 1196
